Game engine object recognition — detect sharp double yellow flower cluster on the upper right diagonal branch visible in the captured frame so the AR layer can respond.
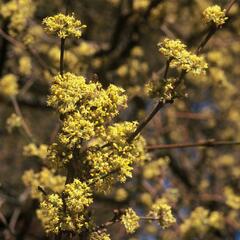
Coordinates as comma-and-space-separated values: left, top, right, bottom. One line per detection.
158, 38, 208, 75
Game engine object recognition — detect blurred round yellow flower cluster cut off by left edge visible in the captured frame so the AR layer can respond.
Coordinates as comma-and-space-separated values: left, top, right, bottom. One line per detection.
0, 74, 18, 97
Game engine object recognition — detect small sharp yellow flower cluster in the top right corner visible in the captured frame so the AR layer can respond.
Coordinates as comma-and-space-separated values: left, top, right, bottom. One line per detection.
203, 5, 228, 26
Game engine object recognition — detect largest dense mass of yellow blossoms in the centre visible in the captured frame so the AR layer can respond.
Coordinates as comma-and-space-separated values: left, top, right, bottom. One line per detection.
48, 73, 146, 189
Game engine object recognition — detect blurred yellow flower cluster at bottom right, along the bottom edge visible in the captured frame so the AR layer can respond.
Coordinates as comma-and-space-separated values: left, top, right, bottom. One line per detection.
180, 207, 224, 238
